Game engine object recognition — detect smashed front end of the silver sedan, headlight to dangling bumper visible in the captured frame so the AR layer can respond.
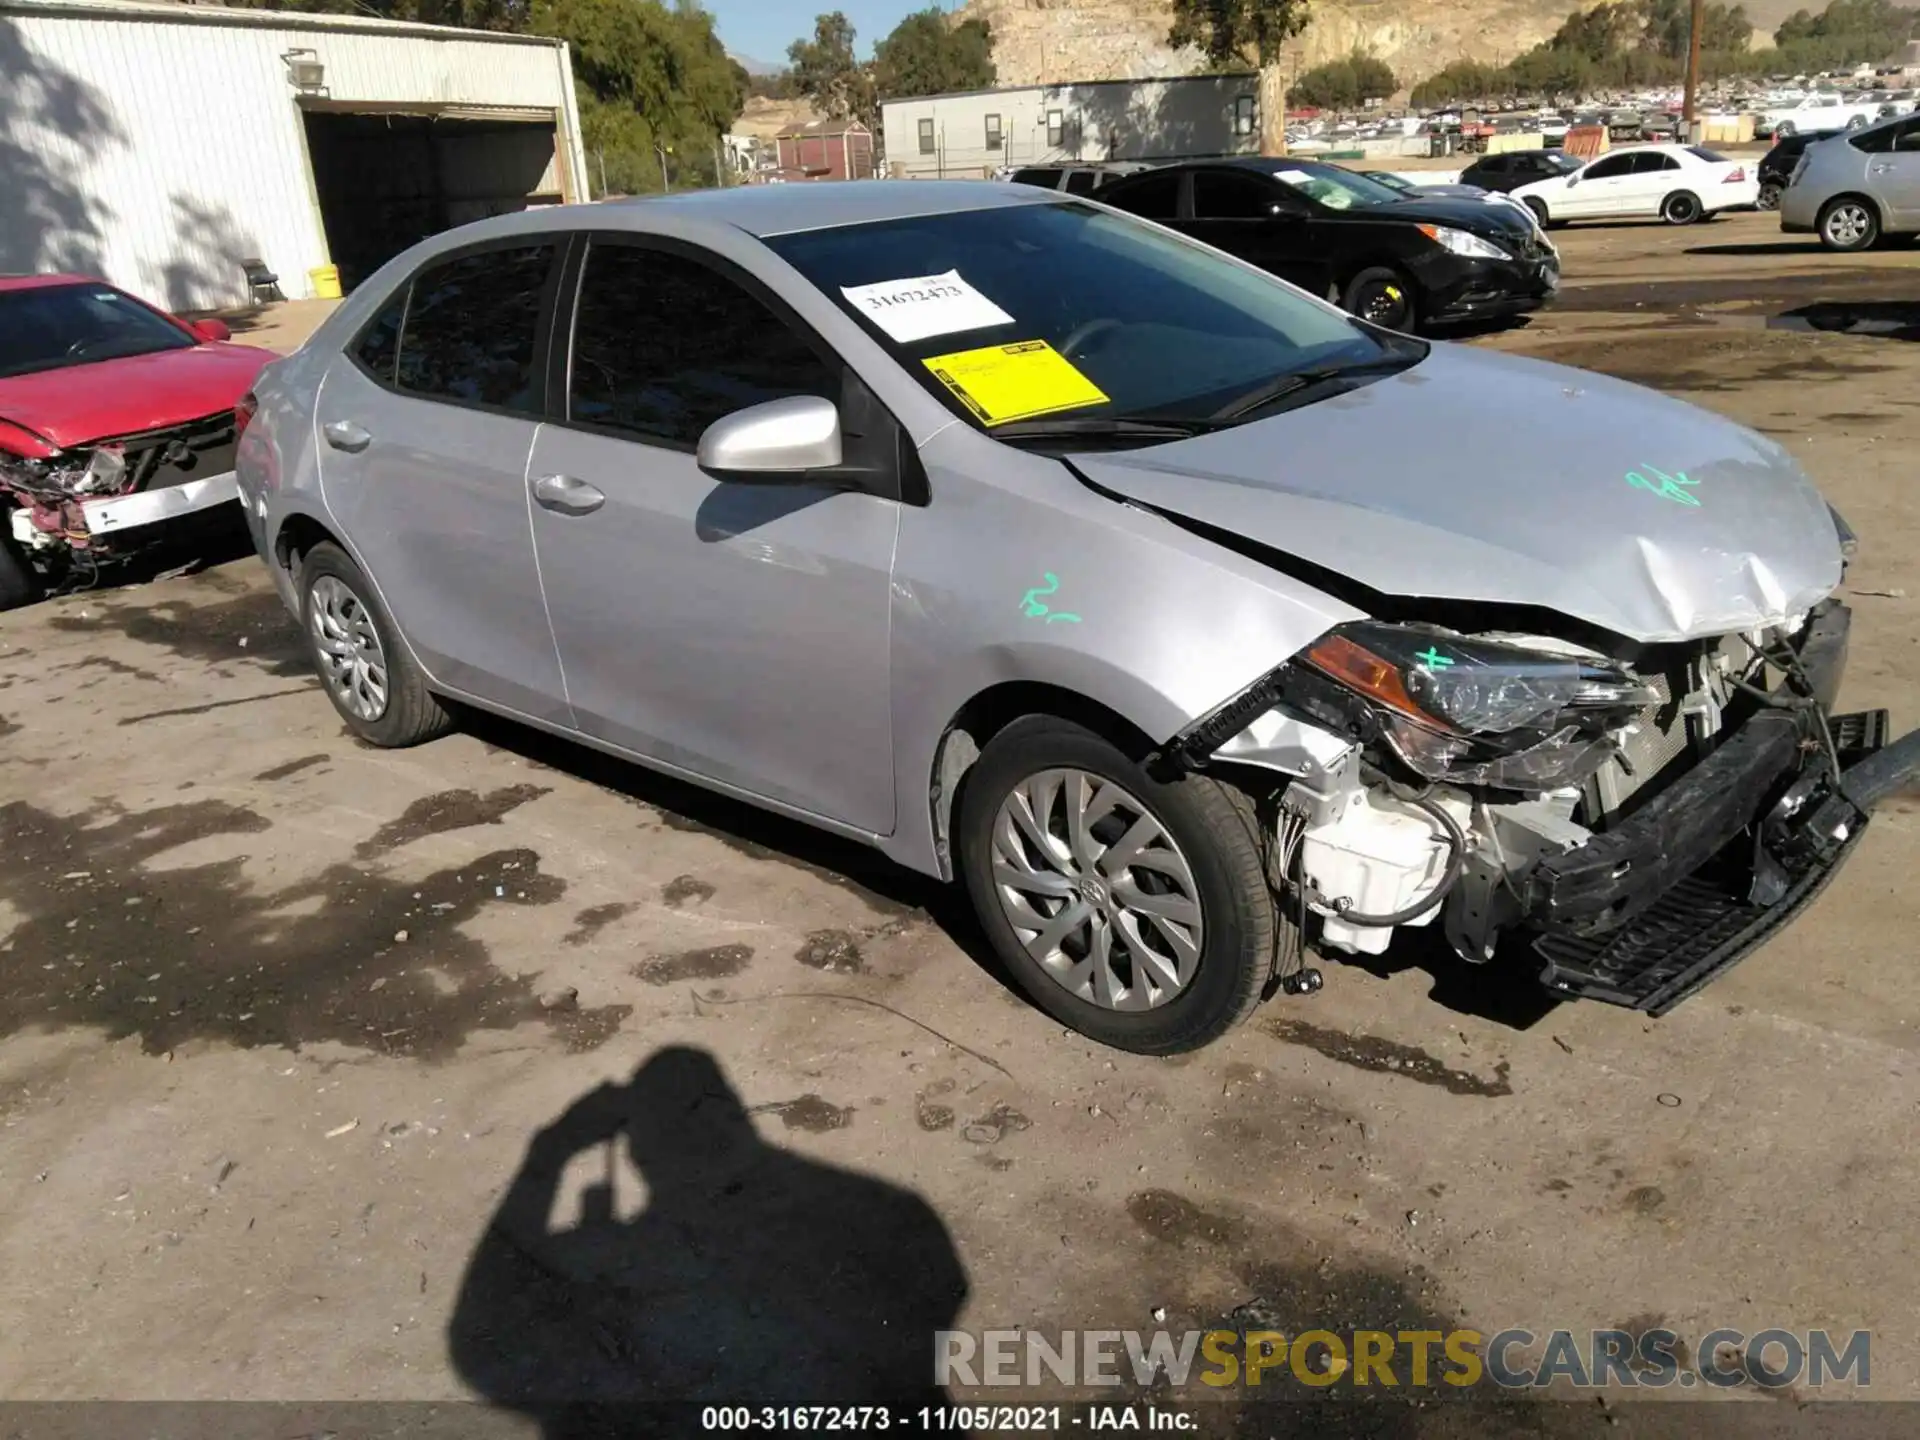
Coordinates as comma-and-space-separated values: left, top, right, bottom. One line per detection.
1162, 599, 1920, 1016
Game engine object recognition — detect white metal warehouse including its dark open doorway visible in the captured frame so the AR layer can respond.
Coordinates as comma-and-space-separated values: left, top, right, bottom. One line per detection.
0, 0, 588, 309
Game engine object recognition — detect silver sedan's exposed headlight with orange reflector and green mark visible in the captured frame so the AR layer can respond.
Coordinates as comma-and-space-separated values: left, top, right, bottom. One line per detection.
1304, 620, 1659, 791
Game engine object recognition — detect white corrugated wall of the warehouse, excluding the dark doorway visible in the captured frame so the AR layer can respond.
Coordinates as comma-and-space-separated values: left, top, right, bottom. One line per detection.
0, 4, 584, 309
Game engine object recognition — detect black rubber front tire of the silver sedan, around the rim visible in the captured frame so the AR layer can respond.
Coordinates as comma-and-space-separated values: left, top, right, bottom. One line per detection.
956, 716, 1277, 1054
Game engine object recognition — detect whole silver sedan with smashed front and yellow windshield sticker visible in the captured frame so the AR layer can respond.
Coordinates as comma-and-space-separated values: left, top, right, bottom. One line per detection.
238, 182, 1920, 1052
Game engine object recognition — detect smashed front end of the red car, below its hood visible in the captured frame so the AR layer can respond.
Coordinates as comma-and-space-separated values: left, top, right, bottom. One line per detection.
0, 411, 238, 593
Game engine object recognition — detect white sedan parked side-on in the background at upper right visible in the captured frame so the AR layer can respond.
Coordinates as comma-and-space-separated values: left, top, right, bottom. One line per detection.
1511, 144, 1761, 225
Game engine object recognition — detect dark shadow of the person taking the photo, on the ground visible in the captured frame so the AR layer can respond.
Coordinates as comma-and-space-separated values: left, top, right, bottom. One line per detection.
449, 1046, 968, 1436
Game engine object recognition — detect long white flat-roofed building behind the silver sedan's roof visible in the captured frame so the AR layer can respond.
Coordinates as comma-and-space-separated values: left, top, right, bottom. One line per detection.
879, 75, 1260, 179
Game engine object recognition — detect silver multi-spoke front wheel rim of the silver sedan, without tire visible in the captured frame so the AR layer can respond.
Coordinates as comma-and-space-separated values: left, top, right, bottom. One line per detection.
993, 770, 1206, 1010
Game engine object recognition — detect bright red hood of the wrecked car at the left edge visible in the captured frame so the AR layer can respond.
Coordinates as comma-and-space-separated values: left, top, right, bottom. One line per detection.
0, 344, 278, 449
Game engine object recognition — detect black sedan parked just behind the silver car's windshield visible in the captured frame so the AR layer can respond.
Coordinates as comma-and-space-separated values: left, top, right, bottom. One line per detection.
1098, 159, 1559, 330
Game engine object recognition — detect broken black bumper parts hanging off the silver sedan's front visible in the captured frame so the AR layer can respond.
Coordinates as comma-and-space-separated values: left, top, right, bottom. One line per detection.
1526, 605, 1920, 1016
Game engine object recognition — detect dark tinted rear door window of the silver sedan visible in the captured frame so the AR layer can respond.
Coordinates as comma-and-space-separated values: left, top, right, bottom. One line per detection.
394, 246, 555, 415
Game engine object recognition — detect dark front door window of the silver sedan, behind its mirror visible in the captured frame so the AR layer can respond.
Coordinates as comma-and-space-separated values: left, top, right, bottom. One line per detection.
566, 244, 839, 449
